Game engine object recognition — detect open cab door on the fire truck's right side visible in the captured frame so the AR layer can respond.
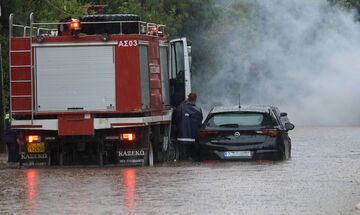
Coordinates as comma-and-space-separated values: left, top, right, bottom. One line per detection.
169, 38, 191, 107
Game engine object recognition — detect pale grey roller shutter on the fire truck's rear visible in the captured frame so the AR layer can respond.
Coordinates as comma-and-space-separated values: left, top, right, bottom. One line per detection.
35, 46, 116, 112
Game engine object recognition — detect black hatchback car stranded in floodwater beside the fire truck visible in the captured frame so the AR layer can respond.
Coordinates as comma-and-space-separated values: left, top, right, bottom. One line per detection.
197, 105, 295, 160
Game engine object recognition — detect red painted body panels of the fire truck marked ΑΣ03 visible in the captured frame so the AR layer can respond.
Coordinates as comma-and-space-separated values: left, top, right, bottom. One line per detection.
11, 34, 167, 135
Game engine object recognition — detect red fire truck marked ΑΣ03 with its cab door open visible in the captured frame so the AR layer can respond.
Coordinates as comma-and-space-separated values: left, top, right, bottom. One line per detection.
9, 14, 191, 166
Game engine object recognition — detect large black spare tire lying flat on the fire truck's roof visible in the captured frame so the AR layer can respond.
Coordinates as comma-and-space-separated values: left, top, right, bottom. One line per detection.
80, 14, 140, 34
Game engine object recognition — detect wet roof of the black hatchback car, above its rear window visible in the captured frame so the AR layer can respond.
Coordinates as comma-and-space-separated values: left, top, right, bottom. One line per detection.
210, 105, 273, 114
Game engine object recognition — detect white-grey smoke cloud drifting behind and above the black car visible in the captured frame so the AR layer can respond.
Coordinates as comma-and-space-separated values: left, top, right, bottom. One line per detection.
192, 0, 360, 125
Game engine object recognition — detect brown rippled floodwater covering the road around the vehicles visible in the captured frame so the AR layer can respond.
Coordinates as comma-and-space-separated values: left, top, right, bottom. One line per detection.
0, 127, 360, 215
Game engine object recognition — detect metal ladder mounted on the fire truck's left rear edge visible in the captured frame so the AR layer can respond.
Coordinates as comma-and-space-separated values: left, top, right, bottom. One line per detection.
9, 13, 52, 125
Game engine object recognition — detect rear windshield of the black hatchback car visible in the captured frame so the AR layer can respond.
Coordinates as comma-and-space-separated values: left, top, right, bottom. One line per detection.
207, 112, 267, 127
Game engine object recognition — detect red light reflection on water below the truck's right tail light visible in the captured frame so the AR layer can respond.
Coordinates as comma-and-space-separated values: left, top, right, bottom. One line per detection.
123, 168, 136, 212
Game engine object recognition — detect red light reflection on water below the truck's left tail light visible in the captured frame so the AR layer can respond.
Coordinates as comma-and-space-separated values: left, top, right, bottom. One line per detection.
26, 169, 39, 212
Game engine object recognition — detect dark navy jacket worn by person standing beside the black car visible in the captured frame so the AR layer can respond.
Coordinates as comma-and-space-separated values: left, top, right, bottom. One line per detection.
175, 103, 203, 144
